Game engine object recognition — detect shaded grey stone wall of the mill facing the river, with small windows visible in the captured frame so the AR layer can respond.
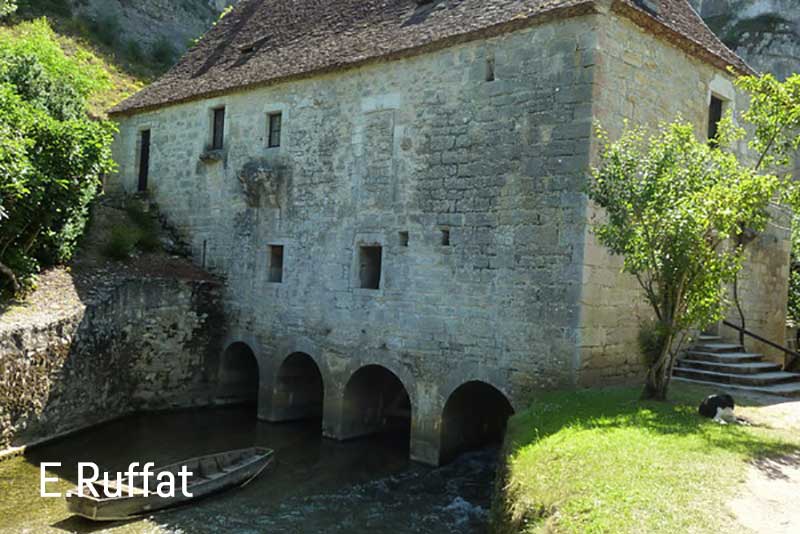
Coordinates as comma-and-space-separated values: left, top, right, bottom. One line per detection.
111, 17, 595, 460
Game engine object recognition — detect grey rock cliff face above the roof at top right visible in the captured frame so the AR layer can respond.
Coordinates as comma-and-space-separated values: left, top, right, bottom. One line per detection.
691, 0, 800, 79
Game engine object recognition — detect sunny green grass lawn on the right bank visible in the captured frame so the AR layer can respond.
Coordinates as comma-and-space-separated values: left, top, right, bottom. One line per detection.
495, 384, 800, 534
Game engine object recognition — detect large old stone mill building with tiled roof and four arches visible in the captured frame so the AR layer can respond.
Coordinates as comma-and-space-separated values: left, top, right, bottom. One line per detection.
108, 0, 788, 464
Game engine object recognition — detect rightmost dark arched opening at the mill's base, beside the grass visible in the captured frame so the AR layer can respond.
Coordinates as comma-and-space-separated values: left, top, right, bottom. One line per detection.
441, 381, 514, 463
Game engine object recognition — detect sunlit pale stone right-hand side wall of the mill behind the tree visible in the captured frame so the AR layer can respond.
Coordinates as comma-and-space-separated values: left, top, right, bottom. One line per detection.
580, 9, 789, 385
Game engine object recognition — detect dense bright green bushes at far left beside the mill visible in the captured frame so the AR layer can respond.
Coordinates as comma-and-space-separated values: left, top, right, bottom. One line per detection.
0, 21, 114, 300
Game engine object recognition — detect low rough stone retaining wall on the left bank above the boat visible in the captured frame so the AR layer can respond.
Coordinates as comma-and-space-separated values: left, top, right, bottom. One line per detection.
0, 279, 222, 450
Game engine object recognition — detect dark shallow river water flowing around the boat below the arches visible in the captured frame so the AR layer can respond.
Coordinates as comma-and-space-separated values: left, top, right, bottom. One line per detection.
0, 408, 497, 534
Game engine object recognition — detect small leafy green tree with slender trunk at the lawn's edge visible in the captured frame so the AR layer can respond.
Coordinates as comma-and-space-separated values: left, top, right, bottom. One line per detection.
588, 116, 781, 399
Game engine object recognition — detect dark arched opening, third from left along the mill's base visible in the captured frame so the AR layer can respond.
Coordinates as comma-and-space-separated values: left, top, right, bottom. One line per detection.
339, 365, 411, 445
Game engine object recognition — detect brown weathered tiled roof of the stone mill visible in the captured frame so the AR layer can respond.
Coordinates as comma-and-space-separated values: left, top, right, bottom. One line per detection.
111, 0, 748, 114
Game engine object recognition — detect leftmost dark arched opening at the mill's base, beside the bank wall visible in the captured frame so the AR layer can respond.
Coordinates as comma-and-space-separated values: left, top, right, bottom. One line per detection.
217, 342, 258, 405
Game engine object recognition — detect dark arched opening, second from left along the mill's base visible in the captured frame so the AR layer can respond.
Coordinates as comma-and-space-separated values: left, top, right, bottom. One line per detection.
270, 352, 324, 422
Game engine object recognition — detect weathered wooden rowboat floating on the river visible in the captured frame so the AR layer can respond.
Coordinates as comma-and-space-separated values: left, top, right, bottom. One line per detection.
66, 447, 274, 521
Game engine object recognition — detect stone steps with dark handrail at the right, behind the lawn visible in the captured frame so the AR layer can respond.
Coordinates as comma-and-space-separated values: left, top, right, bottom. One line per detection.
672, 334, 800, 397
